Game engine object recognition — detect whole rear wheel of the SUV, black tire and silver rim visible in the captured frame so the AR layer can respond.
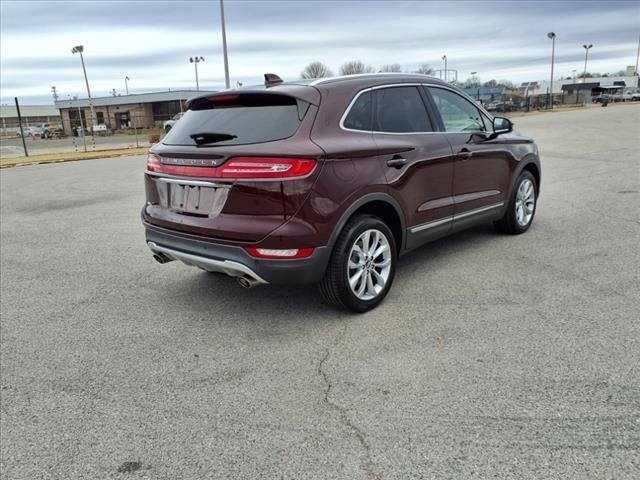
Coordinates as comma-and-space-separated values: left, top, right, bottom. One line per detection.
320, 215, 397, 313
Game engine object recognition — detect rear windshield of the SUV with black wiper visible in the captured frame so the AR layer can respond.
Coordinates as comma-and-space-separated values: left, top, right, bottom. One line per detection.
162, 93, 309, 147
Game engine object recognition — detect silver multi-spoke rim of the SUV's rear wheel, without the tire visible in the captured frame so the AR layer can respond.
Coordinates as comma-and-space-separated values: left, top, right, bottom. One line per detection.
347, 229, 391, 301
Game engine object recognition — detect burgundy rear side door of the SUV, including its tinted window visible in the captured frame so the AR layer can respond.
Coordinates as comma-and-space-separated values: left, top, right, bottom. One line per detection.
372, 84, 454, 249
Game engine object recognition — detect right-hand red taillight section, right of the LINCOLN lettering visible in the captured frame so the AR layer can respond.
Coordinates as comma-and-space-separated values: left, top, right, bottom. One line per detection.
218, 157, 316, 178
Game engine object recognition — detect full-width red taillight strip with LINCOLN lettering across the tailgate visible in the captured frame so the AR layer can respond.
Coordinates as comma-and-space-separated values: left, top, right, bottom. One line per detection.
147, 153, 316, 180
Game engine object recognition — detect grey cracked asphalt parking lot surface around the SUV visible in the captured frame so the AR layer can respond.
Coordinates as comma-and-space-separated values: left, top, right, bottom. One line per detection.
0, 105, 640, 479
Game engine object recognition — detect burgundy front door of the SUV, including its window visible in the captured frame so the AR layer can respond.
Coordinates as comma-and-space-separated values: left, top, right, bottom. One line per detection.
427, 86, 513, 223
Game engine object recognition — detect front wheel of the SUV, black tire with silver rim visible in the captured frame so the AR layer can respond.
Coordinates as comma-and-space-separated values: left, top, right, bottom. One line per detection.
494, 170, 538, 235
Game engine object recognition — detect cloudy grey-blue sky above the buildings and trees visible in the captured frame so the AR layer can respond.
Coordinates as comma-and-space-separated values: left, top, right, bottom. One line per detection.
0, 0, 640, 104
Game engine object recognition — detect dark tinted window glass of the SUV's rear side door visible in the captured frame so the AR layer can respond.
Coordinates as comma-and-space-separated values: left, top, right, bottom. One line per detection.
373, 87, 433, 133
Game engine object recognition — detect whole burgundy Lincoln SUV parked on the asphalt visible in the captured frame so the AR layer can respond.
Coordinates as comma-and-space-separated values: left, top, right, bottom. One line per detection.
142, 74, 540, 312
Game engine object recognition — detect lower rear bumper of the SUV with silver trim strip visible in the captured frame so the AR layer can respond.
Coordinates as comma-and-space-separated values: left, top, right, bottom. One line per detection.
144, 222, 329, 284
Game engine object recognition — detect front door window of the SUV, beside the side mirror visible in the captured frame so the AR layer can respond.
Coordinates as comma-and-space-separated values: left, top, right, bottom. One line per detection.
429, 87, 486, 132
